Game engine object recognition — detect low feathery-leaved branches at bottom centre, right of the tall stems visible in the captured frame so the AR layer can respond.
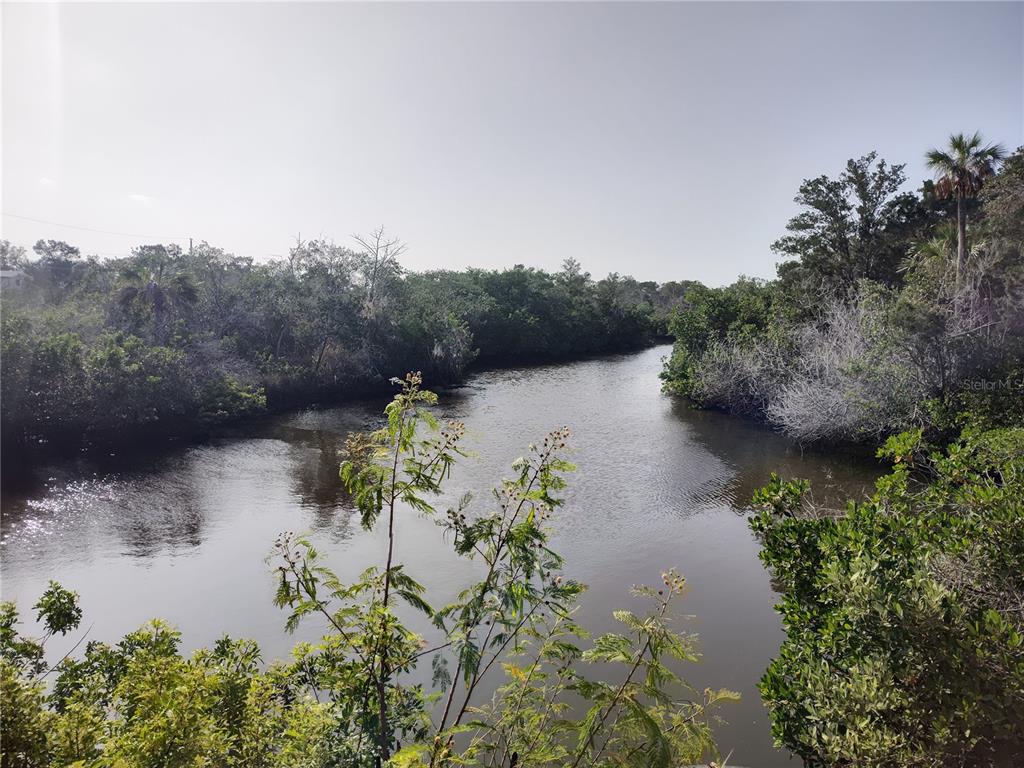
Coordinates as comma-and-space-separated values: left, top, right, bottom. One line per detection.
451, 571, 736, 768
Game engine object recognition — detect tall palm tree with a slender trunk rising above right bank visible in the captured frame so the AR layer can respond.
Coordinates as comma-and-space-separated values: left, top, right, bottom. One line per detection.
925, 132, 1007, 285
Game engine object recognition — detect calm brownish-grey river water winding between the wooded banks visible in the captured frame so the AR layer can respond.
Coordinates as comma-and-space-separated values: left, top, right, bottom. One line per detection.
0, 347, 878, 767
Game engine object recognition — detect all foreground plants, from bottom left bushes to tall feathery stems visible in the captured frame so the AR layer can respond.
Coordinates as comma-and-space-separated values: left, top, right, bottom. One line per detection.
0, 375, 734, 768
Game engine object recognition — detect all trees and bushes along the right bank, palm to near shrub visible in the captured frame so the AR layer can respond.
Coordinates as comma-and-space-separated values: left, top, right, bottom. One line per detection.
664, 135, 1024, 768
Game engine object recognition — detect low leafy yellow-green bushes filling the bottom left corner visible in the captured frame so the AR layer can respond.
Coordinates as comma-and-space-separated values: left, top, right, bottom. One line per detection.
0, 614, 333, 768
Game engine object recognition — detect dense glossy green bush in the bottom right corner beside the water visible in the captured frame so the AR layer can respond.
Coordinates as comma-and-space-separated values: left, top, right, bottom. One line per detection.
752, 428, 1024, 766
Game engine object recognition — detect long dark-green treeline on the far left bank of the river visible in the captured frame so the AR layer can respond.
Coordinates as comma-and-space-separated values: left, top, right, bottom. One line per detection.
0, 231, 682, 457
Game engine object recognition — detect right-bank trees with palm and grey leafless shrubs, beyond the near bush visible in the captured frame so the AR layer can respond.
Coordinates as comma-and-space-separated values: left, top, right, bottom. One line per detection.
665, 135, 1024, 444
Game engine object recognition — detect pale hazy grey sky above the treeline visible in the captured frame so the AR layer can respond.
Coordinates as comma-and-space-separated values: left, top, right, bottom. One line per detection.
0, 2, 1024, 285
